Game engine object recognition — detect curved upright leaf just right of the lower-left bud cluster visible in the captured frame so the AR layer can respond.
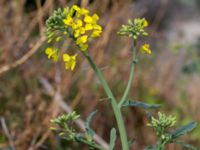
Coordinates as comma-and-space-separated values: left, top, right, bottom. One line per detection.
85, 110, 97, 137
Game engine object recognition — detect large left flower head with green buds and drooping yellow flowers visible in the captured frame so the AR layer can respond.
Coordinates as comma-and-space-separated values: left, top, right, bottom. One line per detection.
45, 5, 102, 71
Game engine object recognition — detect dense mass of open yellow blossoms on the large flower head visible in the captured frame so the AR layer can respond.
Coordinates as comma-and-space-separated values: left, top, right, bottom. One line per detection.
63, 5, 102, 51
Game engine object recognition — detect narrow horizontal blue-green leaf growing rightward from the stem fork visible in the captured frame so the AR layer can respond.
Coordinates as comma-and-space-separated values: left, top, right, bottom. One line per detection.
122, 101, 160, 109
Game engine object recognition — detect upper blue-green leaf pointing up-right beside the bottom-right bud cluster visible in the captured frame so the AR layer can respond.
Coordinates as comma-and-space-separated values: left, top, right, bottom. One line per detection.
170, 121, 197, 139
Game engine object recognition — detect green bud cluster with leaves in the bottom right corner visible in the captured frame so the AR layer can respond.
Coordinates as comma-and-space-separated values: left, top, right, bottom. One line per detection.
145, 112, 197, 150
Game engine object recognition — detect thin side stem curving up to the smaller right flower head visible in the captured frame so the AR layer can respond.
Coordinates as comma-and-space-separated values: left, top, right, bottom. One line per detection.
118, 40, 137, 108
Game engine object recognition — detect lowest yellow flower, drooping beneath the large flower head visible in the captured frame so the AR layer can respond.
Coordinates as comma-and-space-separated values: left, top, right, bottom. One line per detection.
63, 53, 77, 71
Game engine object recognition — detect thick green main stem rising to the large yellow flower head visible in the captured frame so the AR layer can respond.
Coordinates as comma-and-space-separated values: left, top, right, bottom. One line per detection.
83, 53, 129, 150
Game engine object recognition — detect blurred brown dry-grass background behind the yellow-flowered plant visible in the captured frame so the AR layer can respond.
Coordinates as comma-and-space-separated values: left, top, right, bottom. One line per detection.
0, 0, 200, 150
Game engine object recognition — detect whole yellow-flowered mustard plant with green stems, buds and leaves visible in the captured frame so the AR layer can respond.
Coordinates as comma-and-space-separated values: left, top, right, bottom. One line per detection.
45, 5, 196, 150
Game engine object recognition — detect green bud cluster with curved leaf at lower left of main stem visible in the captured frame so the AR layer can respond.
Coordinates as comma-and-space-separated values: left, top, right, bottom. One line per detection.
51, 111, 106, 150
